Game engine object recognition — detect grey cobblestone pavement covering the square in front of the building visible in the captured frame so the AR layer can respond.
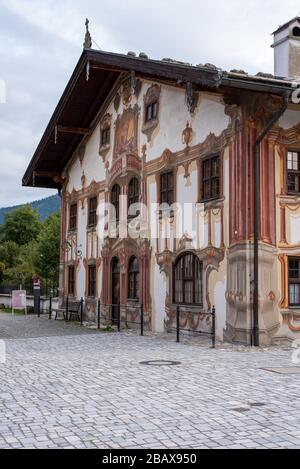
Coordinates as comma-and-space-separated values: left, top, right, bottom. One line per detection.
0, 315, 300, 449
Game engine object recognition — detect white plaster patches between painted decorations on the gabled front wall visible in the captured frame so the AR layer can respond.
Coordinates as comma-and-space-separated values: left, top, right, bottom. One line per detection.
67, 77, 230, 331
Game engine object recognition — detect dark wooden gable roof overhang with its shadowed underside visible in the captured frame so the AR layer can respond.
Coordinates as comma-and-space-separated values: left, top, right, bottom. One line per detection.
23, 49, 221, 189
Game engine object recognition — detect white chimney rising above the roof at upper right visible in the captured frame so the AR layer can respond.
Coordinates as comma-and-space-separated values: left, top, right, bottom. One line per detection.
271, 16, 300, 80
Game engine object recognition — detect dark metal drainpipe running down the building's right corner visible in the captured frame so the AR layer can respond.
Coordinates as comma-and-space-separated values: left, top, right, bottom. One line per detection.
253, 91, 291, 347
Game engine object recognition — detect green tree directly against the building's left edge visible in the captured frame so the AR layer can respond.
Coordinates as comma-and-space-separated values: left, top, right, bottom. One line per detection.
34, 213, 60, 283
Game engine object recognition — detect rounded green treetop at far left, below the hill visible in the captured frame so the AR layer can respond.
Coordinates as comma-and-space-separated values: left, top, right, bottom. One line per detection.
1, 205, 41, 246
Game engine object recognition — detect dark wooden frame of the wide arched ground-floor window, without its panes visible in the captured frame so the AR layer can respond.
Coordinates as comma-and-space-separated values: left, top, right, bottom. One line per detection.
173, 251, 203, 307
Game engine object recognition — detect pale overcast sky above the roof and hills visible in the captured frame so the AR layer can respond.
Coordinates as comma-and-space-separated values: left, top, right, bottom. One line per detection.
0, 0, 300, 207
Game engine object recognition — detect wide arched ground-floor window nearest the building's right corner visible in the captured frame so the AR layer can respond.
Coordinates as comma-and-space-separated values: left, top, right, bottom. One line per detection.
173, 253, 202, 306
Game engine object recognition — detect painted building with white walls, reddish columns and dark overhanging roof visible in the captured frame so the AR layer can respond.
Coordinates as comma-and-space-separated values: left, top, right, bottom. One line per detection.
23, 19, 300, 344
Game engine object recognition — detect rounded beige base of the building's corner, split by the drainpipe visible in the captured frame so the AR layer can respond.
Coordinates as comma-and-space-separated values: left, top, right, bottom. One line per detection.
224, 242, 280, 346
